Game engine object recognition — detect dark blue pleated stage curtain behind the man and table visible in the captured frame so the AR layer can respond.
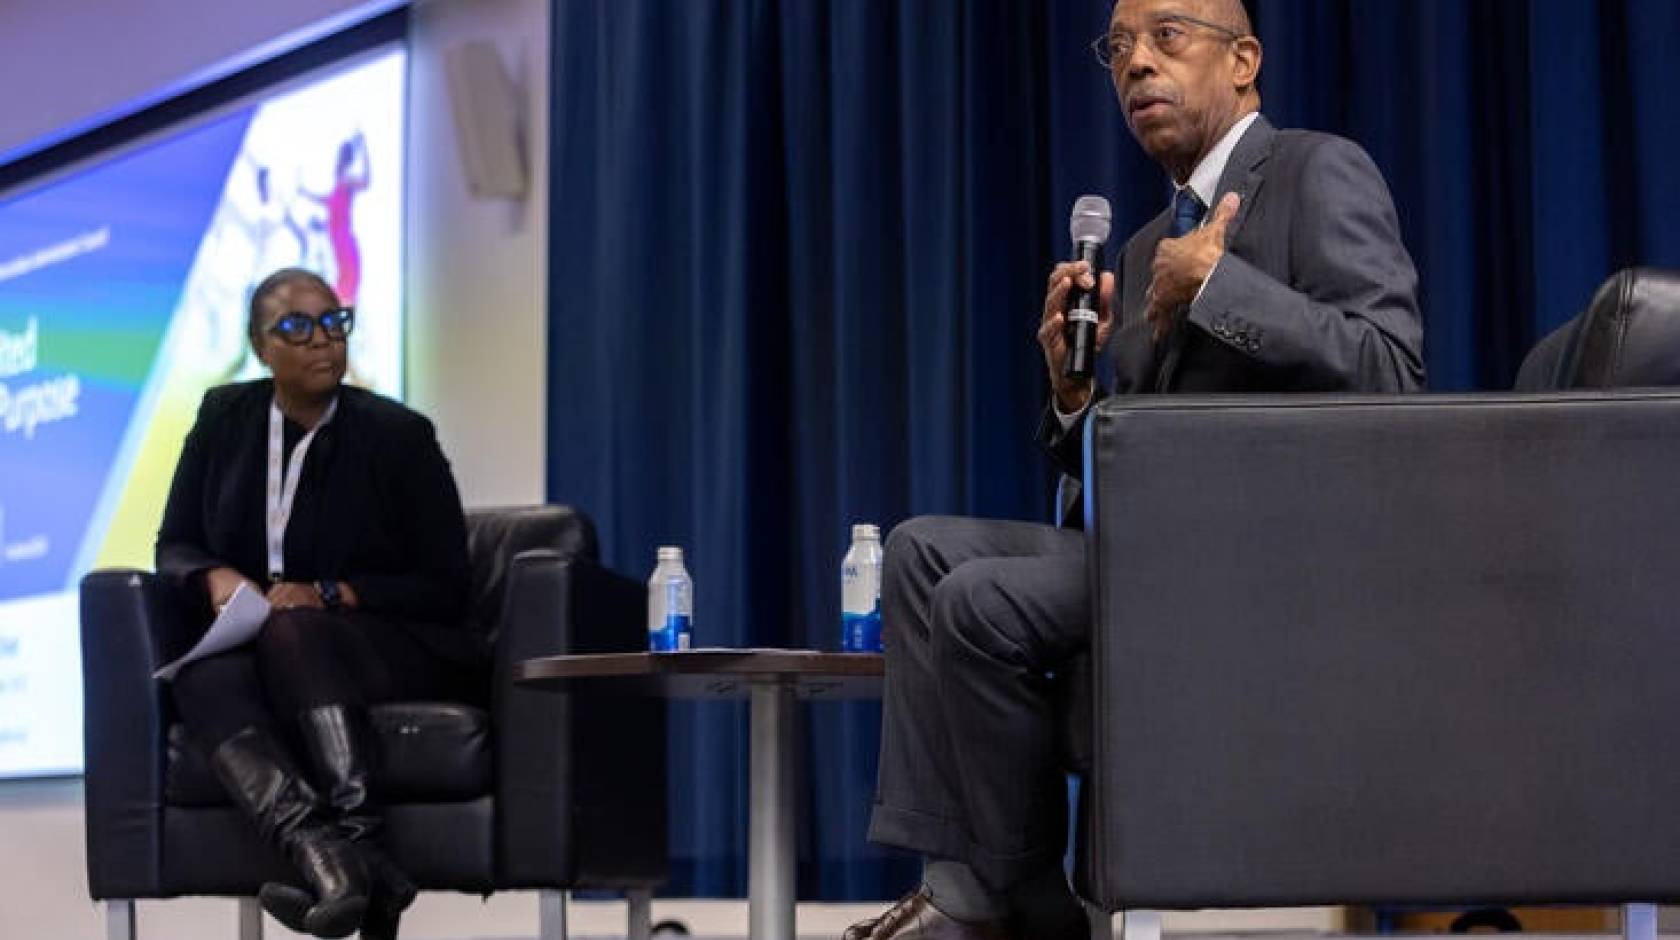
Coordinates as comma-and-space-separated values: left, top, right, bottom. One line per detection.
548, 0, 1680, 900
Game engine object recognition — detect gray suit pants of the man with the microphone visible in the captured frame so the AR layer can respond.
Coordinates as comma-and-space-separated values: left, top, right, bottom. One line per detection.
869, 517, 1090, 890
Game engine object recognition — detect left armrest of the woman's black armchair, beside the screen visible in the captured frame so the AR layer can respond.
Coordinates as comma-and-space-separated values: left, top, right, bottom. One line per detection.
81, 569, 186, 900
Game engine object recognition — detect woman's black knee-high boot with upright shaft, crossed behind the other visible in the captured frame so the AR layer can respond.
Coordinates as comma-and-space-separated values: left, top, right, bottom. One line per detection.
264, 705, 417, 940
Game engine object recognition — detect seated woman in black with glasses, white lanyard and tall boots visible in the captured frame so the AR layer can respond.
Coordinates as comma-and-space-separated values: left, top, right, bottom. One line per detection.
158, 269, 489, 938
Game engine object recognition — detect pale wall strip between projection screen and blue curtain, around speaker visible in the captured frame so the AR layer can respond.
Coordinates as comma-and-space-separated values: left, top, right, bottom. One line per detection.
408, 0, 549, 507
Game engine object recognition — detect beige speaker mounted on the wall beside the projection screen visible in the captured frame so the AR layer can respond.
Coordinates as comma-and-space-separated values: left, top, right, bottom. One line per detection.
444, 40, 528, 200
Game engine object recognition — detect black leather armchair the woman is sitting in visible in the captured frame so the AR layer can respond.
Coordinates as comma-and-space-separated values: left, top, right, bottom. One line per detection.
82, 507, 667, 940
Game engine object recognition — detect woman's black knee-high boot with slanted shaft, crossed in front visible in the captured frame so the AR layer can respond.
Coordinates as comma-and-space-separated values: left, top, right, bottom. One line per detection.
210, 727, 370, 937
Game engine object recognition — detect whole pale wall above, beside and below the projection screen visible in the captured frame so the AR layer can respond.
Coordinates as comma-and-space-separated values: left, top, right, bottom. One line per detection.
0, 0, 547, 940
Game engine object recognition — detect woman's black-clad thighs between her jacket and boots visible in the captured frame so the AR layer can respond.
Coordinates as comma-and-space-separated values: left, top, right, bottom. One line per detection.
171, 608, 469, 750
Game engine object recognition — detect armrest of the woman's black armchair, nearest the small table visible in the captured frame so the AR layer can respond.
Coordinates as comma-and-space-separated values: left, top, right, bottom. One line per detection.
492, 549, 667, 888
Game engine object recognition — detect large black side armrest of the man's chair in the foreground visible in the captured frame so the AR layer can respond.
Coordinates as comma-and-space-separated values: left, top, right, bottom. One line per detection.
1080, 393, 1680, 910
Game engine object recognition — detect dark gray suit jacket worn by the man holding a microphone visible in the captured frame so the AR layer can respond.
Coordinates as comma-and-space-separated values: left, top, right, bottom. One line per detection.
1038, 116, 1423, 490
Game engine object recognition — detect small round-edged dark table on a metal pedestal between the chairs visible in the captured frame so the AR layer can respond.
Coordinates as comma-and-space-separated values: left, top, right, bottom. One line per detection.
514, 650, 885, 940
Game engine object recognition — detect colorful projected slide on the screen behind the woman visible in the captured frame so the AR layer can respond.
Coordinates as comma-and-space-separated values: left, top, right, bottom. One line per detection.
0, 50, 405, 777
